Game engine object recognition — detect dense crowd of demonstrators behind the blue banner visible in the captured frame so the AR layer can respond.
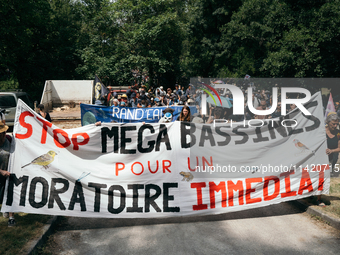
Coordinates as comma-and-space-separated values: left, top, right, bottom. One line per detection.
96, 80, 332, 123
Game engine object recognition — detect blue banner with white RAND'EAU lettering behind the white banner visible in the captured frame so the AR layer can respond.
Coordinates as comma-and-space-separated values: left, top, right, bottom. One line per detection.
80, 104, 197, 126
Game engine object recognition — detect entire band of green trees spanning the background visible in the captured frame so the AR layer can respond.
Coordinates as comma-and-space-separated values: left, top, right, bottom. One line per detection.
0, 0, 340, 95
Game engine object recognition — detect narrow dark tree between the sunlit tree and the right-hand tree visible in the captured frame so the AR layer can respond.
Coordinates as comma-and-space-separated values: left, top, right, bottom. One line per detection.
183, 0, 242, 77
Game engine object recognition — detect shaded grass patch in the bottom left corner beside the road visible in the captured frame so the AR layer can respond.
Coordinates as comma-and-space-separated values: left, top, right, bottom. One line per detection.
0, 207, 52, 255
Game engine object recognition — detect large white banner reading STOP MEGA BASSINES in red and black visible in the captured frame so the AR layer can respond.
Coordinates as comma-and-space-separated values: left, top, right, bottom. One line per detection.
2, 93, 330, 218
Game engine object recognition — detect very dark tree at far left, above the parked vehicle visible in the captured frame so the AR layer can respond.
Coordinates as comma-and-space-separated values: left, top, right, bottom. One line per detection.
0, 0, 83, 99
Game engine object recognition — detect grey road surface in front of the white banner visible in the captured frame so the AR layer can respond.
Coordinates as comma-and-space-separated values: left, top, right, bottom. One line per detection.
44, 202, 340, 255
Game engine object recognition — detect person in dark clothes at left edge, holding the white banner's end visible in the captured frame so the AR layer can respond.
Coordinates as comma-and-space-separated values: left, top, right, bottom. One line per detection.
0, 122, 15, 227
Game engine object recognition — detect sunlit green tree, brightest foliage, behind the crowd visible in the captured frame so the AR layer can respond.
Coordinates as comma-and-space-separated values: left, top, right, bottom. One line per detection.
77, 0, 183, 88
